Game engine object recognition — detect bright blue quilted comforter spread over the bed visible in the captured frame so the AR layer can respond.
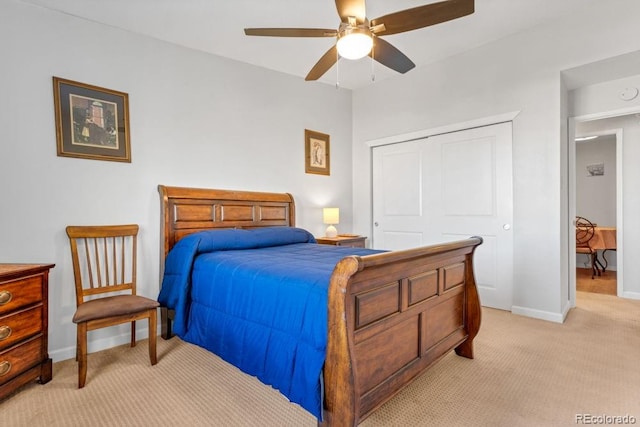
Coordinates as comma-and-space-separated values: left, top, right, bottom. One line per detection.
158, 227, 378, 419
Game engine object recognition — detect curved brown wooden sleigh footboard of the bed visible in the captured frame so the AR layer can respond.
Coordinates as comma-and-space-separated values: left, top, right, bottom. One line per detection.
320, 237, 482, 426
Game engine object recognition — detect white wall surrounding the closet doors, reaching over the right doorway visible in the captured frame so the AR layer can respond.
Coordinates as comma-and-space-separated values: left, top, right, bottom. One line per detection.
353, 0, 640, 321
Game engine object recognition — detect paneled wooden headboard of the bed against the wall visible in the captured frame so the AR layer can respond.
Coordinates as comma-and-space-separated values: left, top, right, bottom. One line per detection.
158, 185, 296, 260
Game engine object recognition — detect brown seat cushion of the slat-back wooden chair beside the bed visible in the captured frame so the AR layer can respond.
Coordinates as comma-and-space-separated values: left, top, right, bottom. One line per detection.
73, 295, 160, 323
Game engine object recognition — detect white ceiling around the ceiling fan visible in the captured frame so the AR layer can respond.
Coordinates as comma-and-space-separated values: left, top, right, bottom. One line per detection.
22, 0, 600, 89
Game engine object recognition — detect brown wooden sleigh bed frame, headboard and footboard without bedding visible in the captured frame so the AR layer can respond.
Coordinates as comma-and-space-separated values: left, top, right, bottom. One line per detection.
158, 185, 482, 427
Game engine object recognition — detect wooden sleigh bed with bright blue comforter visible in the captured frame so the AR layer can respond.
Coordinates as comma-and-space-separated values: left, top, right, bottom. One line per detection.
158, 185, 482, 426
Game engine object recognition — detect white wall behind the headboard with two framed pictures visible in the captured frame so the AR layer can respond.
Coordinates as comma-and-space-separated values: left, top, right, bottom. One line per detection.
0, 0, 352, 360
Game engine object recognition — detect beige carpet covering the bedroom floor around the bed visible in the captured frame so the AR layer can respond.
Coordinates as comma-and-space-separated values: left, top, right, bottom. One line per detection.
0, 292, 640, 427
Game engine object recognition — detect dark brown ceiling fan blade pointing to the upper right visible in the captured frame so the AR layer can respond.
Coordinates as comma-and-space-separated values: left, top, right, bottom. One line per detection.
370, 0, 475, 36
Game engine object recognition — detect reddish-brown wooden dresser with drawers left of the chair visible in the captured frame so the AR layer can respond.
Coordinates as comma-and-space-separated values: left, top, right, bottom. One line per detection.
0, 264, 54, 399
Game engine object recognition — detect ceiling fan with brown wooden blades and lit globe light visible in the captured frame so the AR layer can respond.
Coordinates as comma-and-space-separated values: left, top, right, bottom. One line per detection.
244, 0, 474, 80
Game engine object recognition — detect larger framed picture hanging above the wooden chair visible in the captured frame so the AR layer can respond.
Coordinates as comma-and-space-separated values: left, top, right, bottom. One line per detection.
53, 77, 131, 163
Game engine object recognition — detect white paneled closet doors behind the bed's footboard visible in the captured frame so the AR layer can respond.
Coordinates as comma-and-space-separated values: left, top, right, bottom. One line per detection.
373, 123, 513, 310
